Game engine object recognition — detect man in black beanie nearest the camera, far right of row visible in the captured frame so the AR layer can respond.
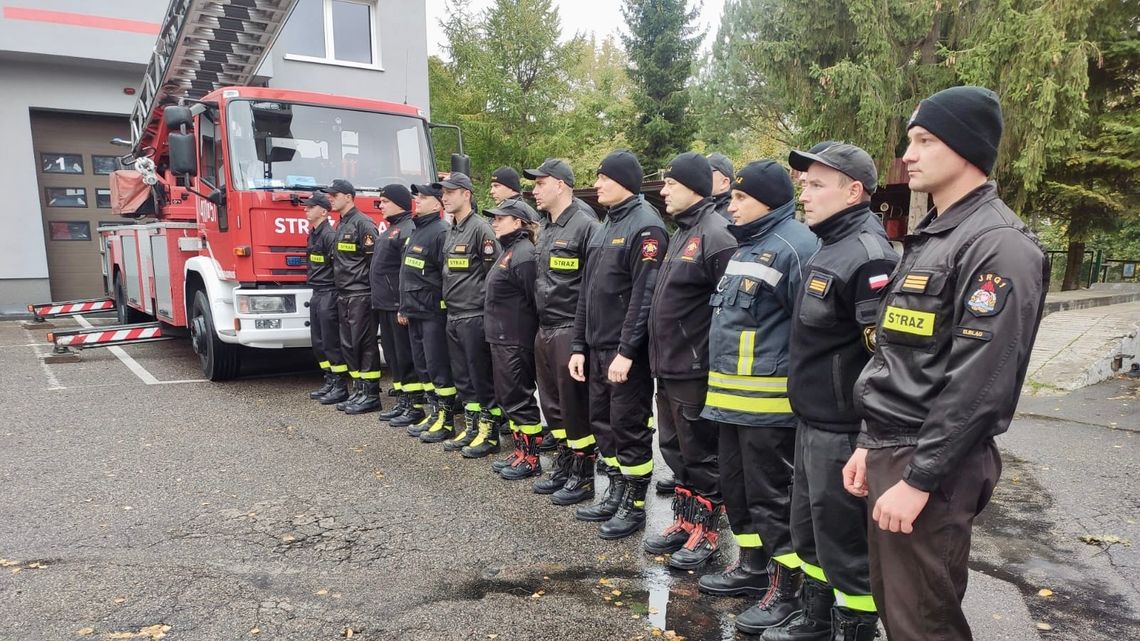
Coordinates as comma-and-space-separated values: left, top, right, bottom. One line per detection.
844, 87, 1049, 641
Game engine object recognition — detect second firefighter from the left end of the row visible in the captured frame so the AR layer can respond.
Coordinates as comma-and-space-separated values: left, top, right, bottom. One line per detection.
321, 178, 381, 414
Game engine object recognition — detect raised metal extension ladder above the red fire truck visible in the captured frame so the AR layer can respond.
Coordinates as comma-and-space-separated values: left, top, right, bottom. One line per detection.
131, 0, 296, 147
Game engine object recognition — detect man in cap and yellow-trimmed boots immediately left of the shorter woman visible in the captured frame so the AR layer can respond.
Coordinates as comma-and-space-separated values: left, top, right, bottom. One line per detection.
430, 171, 503, 451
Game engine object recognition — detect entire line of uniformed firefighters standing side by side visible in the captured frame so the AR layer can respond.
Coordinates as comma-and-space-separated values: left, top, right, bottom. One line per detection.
304, 88, 1047, 641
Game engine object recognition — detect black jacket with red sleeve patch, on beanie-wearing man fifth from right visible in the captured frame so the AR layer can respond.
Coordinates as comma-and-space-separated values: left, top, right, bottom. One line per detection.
571, 195, 669, 358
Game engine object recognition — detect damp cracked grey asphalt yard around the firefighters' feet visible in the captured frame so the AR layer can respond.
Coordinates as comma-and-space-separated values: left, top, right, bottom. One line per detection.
0, 318, 1140, 641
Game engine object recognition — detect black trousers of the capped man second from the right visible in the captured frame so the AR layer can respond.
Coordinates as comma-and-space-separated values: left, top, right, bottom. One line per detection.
791, 421, 874, 612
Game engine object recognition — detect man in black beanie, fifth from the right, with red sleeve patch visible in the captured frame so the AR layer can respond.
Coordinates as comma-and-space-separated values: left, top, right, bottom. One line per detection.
569, 151, 669, 539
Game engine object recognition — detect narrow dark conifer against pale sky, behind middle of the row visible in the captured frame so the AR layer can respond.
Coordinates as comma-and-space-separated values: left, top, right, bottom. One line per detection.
621, 0, 700, 173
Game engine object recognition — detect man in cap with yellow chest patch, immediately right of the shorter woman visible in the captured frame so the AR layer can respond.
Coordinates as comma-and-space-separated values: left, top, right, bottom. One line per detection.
522, 159, 601, 505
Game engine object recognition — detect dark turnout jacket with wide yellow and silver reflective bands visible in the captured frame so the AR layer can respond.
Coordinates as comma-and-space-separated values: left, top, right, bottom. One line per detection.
701, 201, 820, 428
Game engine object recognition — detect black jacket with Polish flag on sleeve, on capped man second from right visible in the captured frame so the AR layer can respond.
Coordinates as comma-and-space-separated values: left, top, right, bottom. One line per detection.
788, 204, 898, 432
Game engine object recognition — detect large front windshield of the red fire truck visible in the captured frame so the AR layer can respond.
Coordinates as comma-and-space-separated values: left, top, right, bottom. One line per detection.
227, 100, 431, 190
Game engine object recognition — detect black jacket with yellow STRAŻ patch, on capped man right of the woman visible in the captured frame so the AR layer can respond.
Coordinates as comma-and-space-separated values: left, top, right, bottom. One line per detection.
535, 198, 602, 327
